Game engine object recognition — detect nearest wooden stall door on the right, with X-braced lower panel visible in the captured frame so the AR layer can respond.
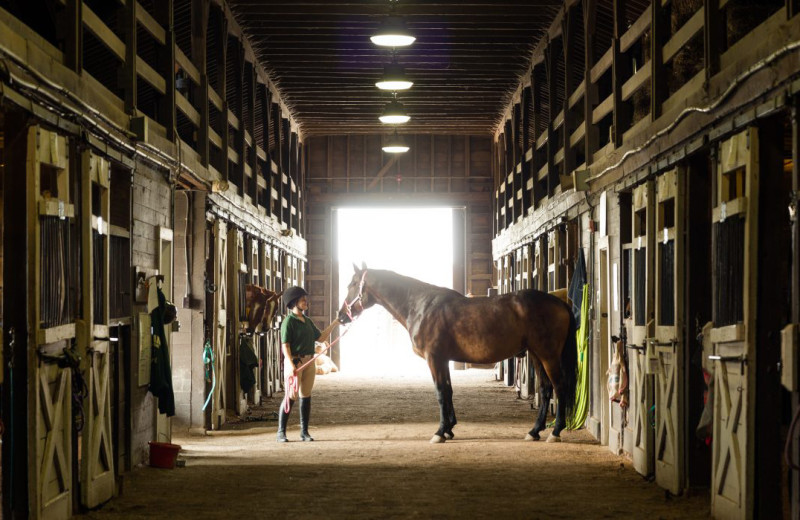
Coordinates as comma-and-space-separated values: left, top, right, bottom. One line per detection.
710, 128, 758, 518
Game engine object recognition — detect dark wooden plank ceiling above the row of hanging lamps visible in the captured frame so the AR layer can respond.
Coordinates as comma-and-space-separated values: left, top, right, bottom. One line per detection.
229, 0, 562, 135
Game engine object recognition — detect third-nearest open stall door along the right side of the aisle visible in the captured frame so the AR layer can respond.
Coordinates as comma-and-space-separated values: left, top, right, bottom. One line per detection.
628, 181, 654, 475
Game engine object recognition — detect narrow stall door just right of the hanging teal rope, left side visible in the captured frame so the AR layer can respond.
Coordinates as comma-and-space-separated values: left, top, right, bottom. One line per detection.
211, 220, 228, 430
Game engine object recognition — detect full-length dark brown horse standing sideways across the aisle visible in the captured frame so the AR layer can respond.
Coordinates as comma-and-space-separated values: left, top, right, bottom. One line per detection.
338, 264, 578, 442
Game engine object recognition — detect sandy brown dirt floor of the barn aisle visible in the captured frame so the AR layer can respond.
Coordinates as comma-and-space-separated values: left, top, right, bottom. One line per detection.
86, 369, 709, 520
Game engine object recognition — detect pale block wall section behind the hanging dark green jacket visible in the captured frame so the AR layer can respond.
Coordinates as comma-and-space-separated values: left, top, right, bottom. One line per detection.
131, 162, 172, 466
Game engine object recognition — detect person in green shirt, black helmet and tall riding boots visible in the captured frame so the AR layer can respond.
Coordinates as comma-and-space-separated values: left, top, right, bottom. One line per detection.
277, 286, 321, 442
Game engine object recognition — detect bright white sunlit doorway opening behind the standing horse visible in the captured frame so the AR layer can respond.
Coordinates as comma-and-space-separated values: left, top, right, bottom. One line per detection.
338, 208, 453, 377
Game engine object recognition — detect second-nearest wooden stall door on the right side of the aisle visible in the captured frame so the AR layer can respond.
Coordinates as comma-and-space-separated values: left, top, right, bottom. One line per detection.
650, 169, 686, 494
